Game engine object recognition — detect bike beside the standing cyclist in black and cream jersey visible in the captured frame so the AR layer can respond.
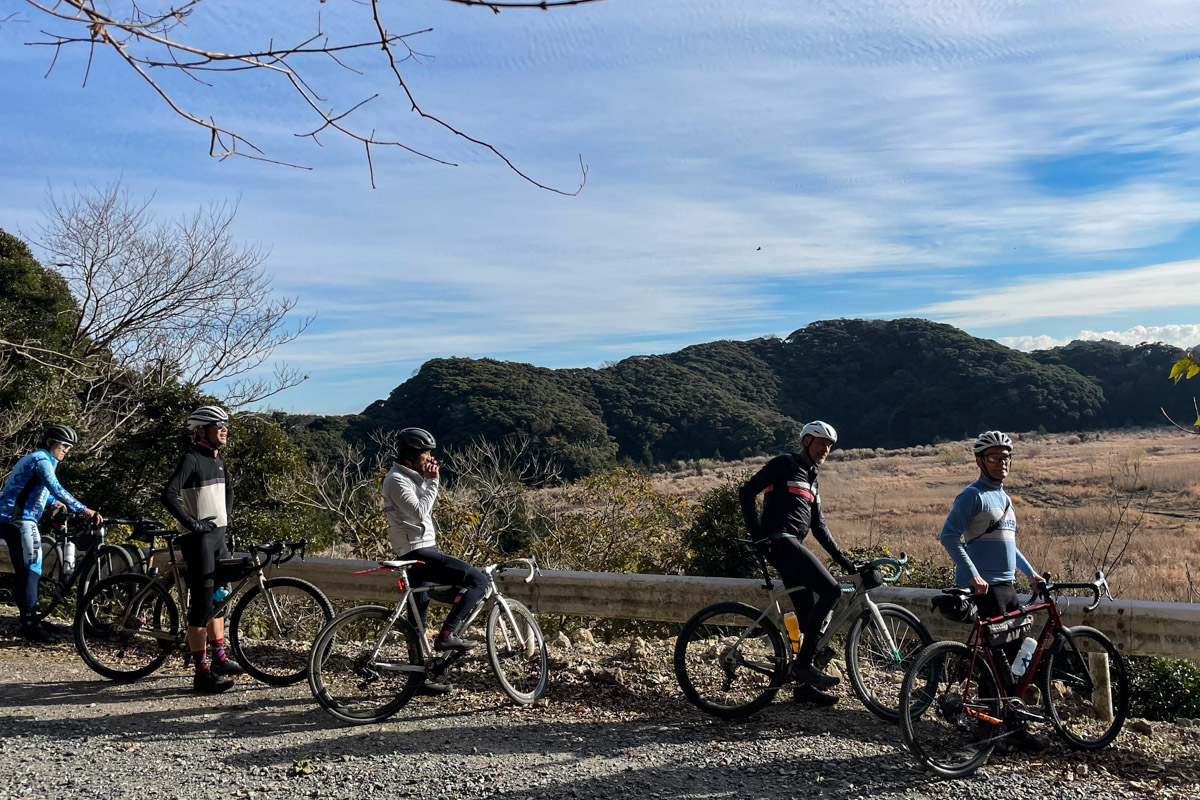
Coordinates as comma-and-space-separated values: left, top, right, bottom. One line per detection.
73, 521, 334, 686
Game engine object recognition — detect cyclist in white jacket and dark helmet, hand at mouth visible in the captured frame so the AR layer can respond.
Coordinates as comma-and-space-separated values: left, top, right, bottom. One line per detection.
383, 428, 487, 650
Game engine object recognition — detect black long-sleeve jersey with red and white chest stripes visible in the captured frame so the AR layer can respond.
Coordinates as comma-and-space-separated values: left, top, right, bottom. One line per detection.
738, 455, 854, 572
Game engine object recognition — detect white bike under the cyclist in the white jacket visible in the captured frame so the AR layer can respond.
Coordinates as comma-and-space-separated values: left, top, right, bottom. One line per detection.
308, 559, 550, 724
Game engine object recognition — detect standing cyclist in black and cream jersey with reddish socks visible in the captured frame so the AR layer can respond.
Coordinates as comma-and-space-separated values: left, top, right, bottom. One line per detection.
161, 405, 242, 693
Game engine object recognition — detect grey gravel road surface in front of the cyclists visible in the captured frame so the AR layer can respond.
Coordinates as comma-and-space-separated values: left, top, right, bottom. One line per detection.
0, 618, 1200, 800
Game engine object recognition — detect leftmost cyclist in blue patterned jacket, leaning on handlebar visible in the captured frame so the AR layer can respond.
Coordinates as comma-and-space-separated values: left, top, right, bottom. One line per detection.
0, 423, 104, 644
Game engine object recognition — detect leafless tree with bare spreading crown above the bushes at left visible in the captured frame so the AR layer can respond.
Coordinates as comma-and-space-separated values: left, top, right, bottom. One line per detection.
37, 184, 311, 407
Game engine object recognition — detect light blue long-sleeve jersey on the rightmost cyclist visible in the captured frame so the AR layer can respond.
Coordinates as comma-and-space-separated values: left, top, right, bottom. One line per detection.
938, 477, 1033, 587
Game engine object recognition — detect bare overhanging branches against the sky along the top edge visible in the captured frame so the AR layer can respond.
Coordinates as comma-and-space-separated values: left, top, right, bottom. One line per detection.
18, 0, 596, 190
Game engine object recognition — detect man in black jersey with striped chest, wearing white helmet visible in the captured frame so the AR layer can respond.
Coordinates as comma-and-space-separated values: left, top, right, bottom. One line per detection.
738, 420, 854, 705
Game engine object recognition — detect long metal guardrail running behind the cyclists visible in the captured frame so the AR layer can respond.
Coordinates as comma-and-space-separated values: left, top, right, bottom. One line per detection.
9, 547, 1200, 661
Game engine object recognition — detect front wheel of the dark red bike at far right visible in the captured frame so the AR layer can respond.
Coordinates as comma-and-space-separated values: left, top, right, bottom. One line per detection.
1042, 625, 1129, 750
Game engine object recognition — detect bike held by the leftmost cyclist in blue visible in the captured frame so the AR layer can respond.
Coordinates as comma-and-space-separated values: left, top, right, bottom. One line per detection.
32, 515, 137, 621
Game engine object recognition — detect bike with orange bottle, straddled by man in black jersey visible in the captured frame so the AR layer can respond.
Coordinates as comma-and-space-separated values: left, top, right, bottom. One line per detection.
674, 540, 934, 722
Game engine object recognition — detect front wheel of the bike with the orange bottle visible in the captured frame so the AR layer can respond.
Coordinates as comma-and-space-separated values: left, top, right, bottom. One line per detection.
846, 603, 934, 722
